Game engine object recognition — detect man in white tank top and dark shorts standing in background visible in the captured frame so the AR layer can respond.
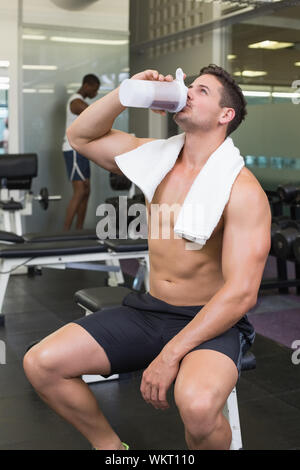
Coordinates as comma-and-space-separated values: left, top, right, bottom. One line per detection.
62, 74, 100, 230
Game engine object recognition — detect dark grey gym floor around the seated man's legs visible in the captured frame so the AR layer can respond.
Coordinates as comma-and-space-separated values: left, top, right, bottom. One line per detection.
0, 258, 300, 450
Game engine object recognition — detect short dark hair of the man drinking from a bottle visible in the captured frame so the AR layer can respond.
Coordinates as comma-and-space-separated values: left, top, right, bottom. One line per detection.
200, 64, 247, 137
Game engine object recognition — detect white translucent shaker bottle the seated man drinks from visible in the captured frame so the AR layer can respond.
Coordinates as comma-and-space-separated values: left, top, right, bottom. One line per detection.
119, 68, 188, 113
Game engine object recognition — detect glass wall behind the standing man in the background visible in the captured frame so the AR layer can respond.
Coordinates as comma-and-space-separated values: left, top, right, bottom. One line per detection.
22, 28, 128, 232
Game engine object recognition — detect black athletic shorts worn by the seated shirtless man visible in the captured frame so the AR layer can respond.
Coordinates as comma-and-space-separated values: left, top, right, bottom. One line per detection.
75, 293, 255, 374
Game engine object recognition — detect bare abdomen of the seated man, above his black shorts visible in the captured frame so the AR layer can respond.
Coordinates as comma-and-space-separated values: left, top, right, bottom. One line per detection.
148, 222, 224, 305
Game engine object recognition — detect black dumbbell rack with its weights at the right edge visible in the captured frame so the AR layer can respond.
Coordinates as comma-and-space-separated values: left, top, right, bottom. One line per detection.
266, 183, 300, 295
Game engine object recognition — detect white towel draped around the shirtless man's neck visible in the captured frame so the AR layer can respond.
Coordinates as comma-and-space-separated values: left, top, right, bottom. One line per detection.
115, 134, 245, 249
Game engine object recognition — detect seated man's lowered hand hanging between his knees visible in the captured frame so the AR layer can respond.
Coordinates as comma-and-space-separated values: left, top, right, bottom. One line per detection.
140, 353, 179, 410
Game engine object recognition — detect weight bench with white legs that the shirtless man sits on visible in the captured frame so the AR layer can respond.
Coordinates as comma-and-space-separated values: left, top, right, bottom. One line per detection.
74, 287, 256, 450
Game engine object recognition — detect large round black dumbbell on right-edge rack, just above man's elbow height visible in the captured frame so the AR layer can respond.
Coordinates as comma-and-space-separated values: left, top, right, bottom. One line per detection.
272, 220, 300, 260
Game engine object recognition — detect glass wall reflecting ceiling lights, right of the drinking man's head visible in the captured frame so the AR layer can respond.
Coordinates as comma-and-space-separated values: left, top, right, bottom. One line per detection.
226, 3, 300, 189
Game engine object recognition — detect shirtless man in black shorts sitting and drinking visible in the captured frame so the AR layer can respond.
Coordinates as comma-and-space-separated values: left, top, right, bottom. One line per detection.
24, 66, 271, 450
